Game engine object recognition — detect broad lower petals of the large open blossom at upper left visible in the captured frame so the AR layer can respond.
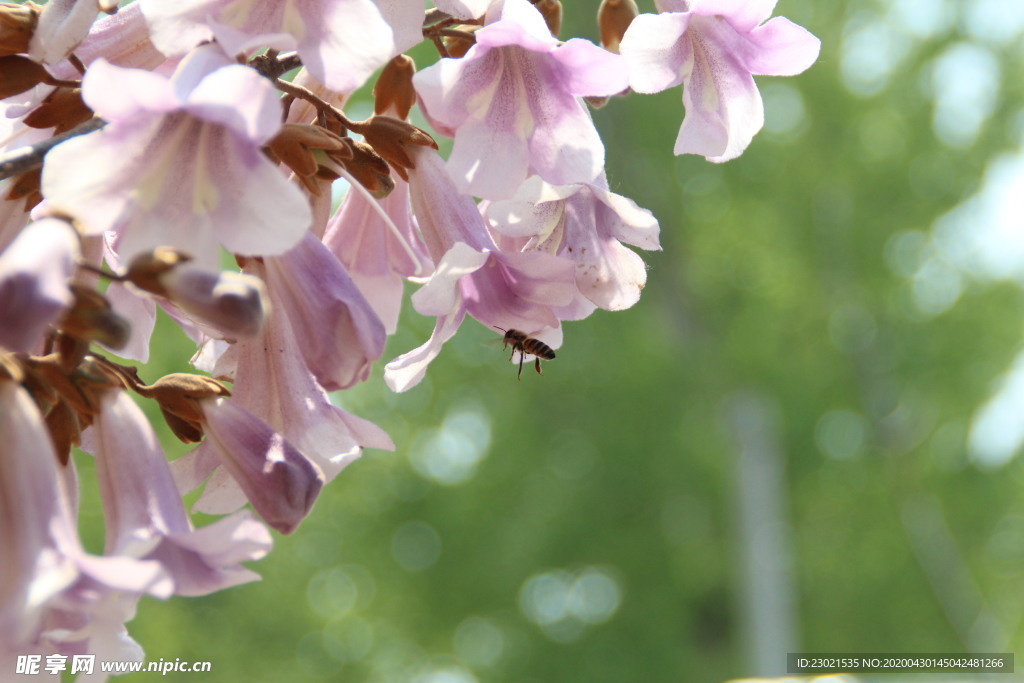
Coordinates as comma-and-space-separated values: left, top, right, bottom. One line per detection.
43, 109, 311, 267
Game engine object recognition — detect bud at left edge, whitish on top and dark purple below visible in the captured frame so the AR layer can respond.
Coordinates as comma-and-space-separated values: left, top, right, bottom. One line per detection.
0, 218, 79, 352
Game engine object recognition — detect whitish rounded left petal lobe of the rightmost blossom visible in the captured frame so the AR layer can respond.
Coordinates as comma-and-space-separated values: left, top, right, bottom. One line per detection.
618, 12, 693, 93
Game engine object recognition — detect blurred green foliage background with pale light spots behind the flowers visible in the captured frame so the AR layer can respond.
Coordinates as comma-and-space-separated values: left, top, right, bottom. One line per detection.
68, 0, 1024, 683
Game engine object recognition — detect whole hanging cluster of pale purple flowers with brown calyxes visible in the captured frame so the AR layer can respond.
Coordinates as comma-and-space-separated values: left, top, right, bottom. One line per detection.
0, 0, 818, 667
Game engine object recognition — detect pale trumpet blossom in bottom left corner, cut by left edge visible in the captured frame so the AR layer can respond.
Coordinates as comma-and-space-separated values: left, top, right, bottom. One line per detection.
0, 380, 173, 661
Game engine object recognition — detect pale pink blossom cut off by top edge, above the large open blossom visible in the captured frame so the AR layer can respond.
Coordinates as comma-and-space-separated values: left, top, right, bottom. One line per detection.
139, 0, 399, 92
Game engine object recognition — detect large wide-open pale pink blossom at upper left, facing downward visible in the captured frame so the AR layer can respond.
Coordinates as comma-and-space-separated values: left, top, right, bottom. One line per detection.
42, 46, 310, 267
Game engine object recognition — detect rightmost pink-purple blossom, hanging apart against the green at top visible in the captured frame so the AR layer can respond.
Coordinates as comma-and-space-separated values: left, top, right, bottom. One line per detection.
620, 0, 821, 162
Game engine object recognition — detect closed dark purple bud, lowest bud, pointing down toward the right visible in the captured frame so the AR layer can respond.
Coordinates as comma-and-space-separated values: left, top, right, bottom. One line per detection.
201, 398, 324, 533
